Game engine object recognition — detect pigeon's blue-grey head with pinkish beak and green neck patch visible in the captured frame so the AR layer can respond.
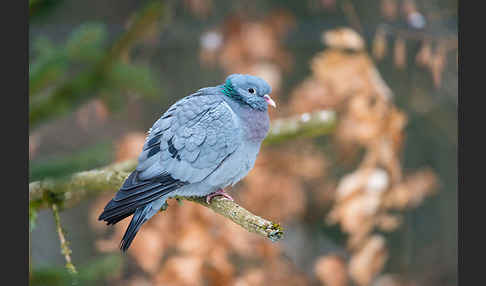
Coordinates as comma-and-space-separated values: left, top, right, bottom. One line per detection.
221, 74, 276, 111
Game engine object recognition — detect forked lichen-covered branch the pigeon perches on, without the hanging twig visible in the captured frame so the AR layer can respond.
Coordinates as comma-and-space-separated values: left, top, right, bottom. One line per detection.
29, 110, 336, 240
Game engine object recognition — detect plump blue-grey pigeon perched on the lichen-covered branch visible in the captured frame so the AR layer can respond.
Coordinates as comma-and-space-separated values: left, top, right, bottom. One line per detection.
98, 74, 276, 252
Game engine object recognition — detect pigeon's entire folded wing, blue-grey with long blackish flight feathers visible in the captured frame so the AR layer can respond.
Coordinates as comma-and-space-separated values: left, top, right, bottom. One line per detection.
99, 90, 241, 228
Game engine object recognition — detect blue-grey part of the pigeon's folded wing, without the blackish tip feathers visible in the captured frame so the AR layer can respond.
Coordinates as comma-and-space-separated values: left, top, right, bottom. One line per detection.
137, 90, 241, 183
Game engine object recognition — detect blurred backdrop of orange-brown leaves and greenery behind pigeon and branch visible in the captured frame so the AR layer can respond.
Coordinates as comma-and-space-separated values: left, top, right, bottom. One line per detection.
29, 0, 458, 286
